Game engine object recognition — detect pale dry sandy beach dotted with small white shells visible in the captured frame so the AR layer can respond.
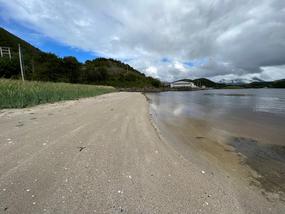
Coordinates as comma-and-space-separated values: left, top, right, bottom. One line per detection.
0, 92, 285, 214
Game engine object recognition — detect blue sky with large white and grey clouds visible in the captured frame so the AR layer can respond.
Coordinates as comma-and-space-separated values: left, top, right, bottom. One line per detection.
0, 0, 285, 81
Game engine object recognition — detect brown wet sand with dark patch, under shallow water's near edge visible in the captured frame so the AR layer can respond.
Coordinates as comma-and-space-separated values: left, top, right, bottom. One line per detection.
152, 115, 285, 202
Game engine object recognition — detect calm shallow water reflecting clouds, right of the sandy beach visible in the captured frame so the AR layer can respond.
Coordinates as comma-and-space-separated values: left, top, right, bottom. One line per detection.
147, 89, 285, 200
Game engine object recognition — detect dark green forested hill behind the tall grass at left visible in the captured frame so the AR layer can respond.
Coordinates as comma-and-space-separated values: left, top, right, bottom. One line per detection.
0, 28, 160, 88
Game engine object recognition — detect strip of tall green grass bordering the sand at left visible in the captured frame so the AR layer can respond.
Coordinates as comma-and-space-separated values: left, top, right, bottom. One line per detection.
0, 79, 115, 109
